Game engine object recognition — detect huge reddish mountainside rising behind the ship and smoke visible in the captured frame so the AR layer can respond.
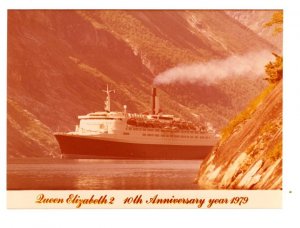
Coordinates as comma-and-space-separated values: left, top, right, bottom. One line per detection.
8, 10, 274, 156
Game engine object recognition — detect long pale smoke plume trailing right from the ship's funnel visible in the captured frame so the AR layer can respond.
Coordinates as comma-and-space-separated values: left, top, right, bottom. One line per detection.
153, 50, 272, 85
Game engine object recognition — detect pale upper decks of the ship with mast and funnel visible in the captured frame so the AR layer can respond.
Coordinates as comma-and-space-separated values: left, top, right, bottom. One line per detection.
67, 87, 218, 146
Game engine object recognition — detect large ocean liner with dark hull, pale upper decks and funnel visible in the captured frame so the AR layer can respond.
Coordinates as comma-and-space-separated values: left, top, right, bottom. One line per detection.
54, 87, 218, 160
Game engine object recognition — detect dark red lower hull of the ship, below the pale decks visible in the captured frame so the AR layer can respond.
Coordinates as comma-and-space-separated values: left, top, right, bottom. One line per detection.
55, 134, 213, 160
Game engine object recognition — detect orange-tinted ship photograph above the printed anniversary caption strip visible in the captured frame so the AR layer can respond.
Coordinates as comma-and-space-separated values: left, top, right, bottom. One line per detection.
7, 9, 284, 192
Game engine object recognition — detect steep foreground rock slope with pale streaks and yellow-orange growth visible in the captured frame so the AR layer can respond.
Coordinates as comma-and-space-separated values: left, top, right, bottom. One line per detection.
197, 82, 282, 189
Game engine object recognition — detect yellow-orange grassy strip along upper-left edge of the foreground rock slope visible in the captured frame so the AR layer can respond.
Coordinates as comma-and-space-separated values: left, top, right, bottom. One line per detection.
221, 84, 275, 142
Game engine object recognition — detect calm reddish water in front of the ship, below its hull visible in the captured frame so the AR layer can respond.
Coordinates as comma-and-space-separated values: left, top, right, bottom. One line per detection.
7, 159, 201, 190
